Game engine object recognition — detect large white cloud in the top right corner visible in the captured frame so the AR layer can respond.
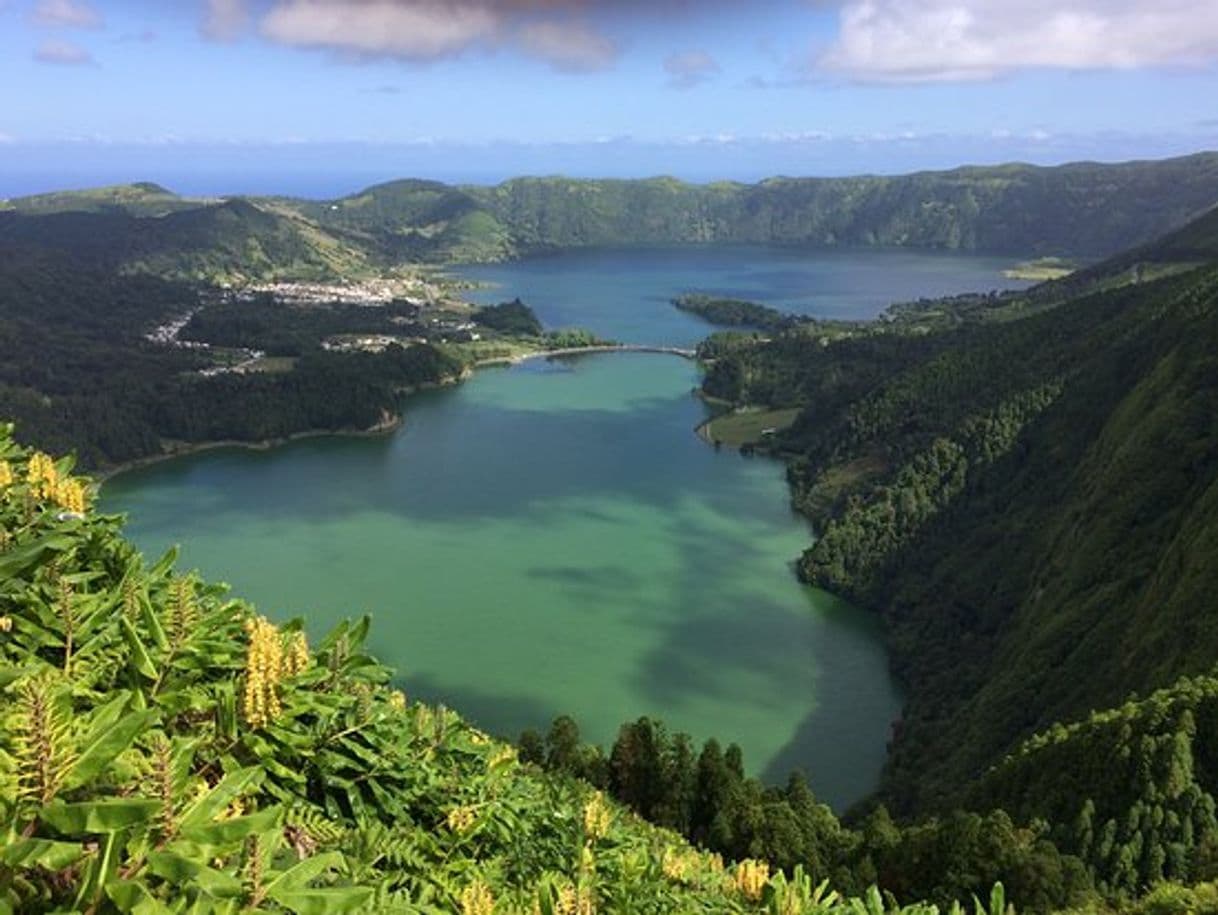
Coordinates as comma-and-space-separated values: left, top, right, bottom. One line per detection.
818, 0, 1218, 82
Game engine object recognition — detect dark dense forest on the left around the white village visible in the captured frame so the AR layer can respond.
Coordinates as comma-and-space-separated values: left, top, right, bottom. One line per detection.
0, 250, 463, 468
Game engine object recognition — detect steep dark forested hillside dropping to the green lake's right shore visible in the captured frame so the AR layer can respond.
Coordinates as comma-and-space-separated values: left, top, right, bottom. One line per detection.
706, 209, 1218, 811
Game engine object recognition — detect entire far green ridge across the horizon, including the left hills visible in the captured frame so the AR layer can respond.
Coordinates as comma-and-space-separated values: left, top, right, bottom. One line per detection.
7, 152, 1218, 271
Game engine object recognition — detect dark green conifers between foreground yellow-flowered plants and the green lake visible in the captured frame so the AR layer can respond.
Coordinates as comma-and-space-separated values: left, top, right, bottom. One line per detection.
520, 716, 1095, 911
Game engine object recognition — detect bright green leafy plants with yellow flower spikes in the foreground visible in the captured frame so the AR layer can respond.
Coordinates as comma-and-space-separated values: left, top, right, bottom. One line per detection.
0, 429, 1007, 915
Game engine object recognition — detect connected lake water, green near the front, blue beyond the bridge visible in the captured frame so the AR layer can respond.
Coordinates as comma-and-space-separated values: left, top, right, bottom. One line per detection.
102, 244, 1027, 808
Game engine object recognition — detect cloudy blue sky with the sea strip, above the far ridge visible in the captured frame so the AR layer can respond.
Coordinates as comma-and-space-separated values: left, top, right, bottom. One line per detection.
0, 0, 1218, 196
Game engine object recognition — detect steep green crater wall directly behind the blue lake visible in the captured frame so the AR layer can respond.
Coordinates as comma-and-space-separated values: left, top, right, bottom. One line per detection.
291, 154, 1218, 260
